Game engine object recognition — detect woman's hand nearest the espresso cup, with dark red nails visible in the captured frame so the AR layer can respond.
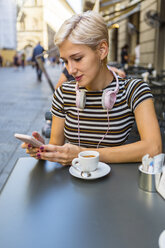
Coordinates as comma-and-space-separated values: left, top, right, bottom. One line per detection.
37, 143, 82, 165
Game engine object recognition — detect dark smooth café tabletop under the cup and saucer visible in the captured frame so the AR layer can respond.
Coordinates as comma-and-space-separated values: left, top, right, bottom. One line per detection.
0, 157, 165, 248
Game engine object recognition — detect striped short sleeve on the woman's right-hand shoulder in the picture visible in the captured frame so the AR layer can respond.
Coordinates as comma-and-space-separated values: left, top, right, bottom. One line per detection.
126, 79, 153, 112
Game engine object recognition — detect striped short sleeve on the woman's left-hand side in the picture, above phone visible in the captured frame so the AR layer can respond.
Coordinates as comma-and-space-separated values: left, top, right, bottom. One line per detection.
51, 87, 65, 118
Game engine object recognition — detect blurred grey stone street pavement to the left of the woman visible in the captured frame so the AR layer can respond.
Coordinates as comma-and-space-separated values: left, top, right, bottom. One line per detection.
0, 66, 62, 190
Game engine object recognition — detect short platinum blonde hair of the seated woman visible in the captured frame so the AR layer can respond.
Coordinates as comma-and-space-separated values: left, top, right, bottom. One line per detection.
55, 11, 109, 49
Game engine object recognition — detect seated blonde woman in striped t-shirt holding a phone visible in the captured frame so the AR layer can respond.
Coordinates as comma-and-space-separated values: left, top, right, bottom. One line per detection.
22, 11, 162, 165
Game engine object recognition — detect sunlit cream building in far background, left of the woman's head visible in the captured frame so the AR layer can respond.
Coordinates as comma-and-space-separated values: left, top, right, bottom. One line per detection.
17, 0, 74, 59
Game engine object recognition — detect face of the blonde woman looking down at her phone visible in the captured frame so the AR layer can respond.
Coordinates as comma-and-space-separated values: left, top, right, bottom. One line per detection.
59, 40, 101, 89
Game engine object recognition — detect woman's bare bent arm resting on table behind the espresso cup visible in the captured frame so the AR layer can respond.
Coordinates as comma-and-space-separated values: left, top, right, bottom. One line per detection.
98, 99, 162, 163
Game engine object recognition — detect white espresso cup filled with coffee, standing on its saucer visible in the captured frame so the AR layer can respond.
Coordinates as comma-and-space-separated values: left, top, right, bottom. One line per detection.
72, 151, 99, 172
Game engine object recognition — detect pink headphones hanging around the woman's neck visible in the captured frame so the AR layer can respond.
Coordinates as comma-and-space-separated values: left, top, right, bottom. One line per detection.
76, 67, 119, 110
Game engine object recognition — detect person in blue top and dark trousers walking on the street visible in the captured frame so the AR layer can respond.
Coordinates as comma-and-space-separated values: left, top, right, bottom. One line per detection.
32, 42, 44, 82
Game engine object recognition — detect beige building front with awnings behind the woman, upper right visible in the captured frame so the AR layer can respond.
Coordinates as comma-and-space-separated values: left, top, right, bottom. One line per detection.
83, 0, 165, 72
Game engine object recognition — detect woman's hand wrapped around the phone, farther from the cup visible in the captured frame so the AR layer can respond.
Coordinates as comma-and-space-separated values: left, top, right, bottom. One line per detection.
21, 132, 45, 159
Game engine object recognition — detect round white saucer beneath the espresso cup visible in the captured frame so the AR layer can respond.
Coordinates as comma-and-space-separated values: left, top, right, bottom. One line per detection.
69, 162, 111, 180
